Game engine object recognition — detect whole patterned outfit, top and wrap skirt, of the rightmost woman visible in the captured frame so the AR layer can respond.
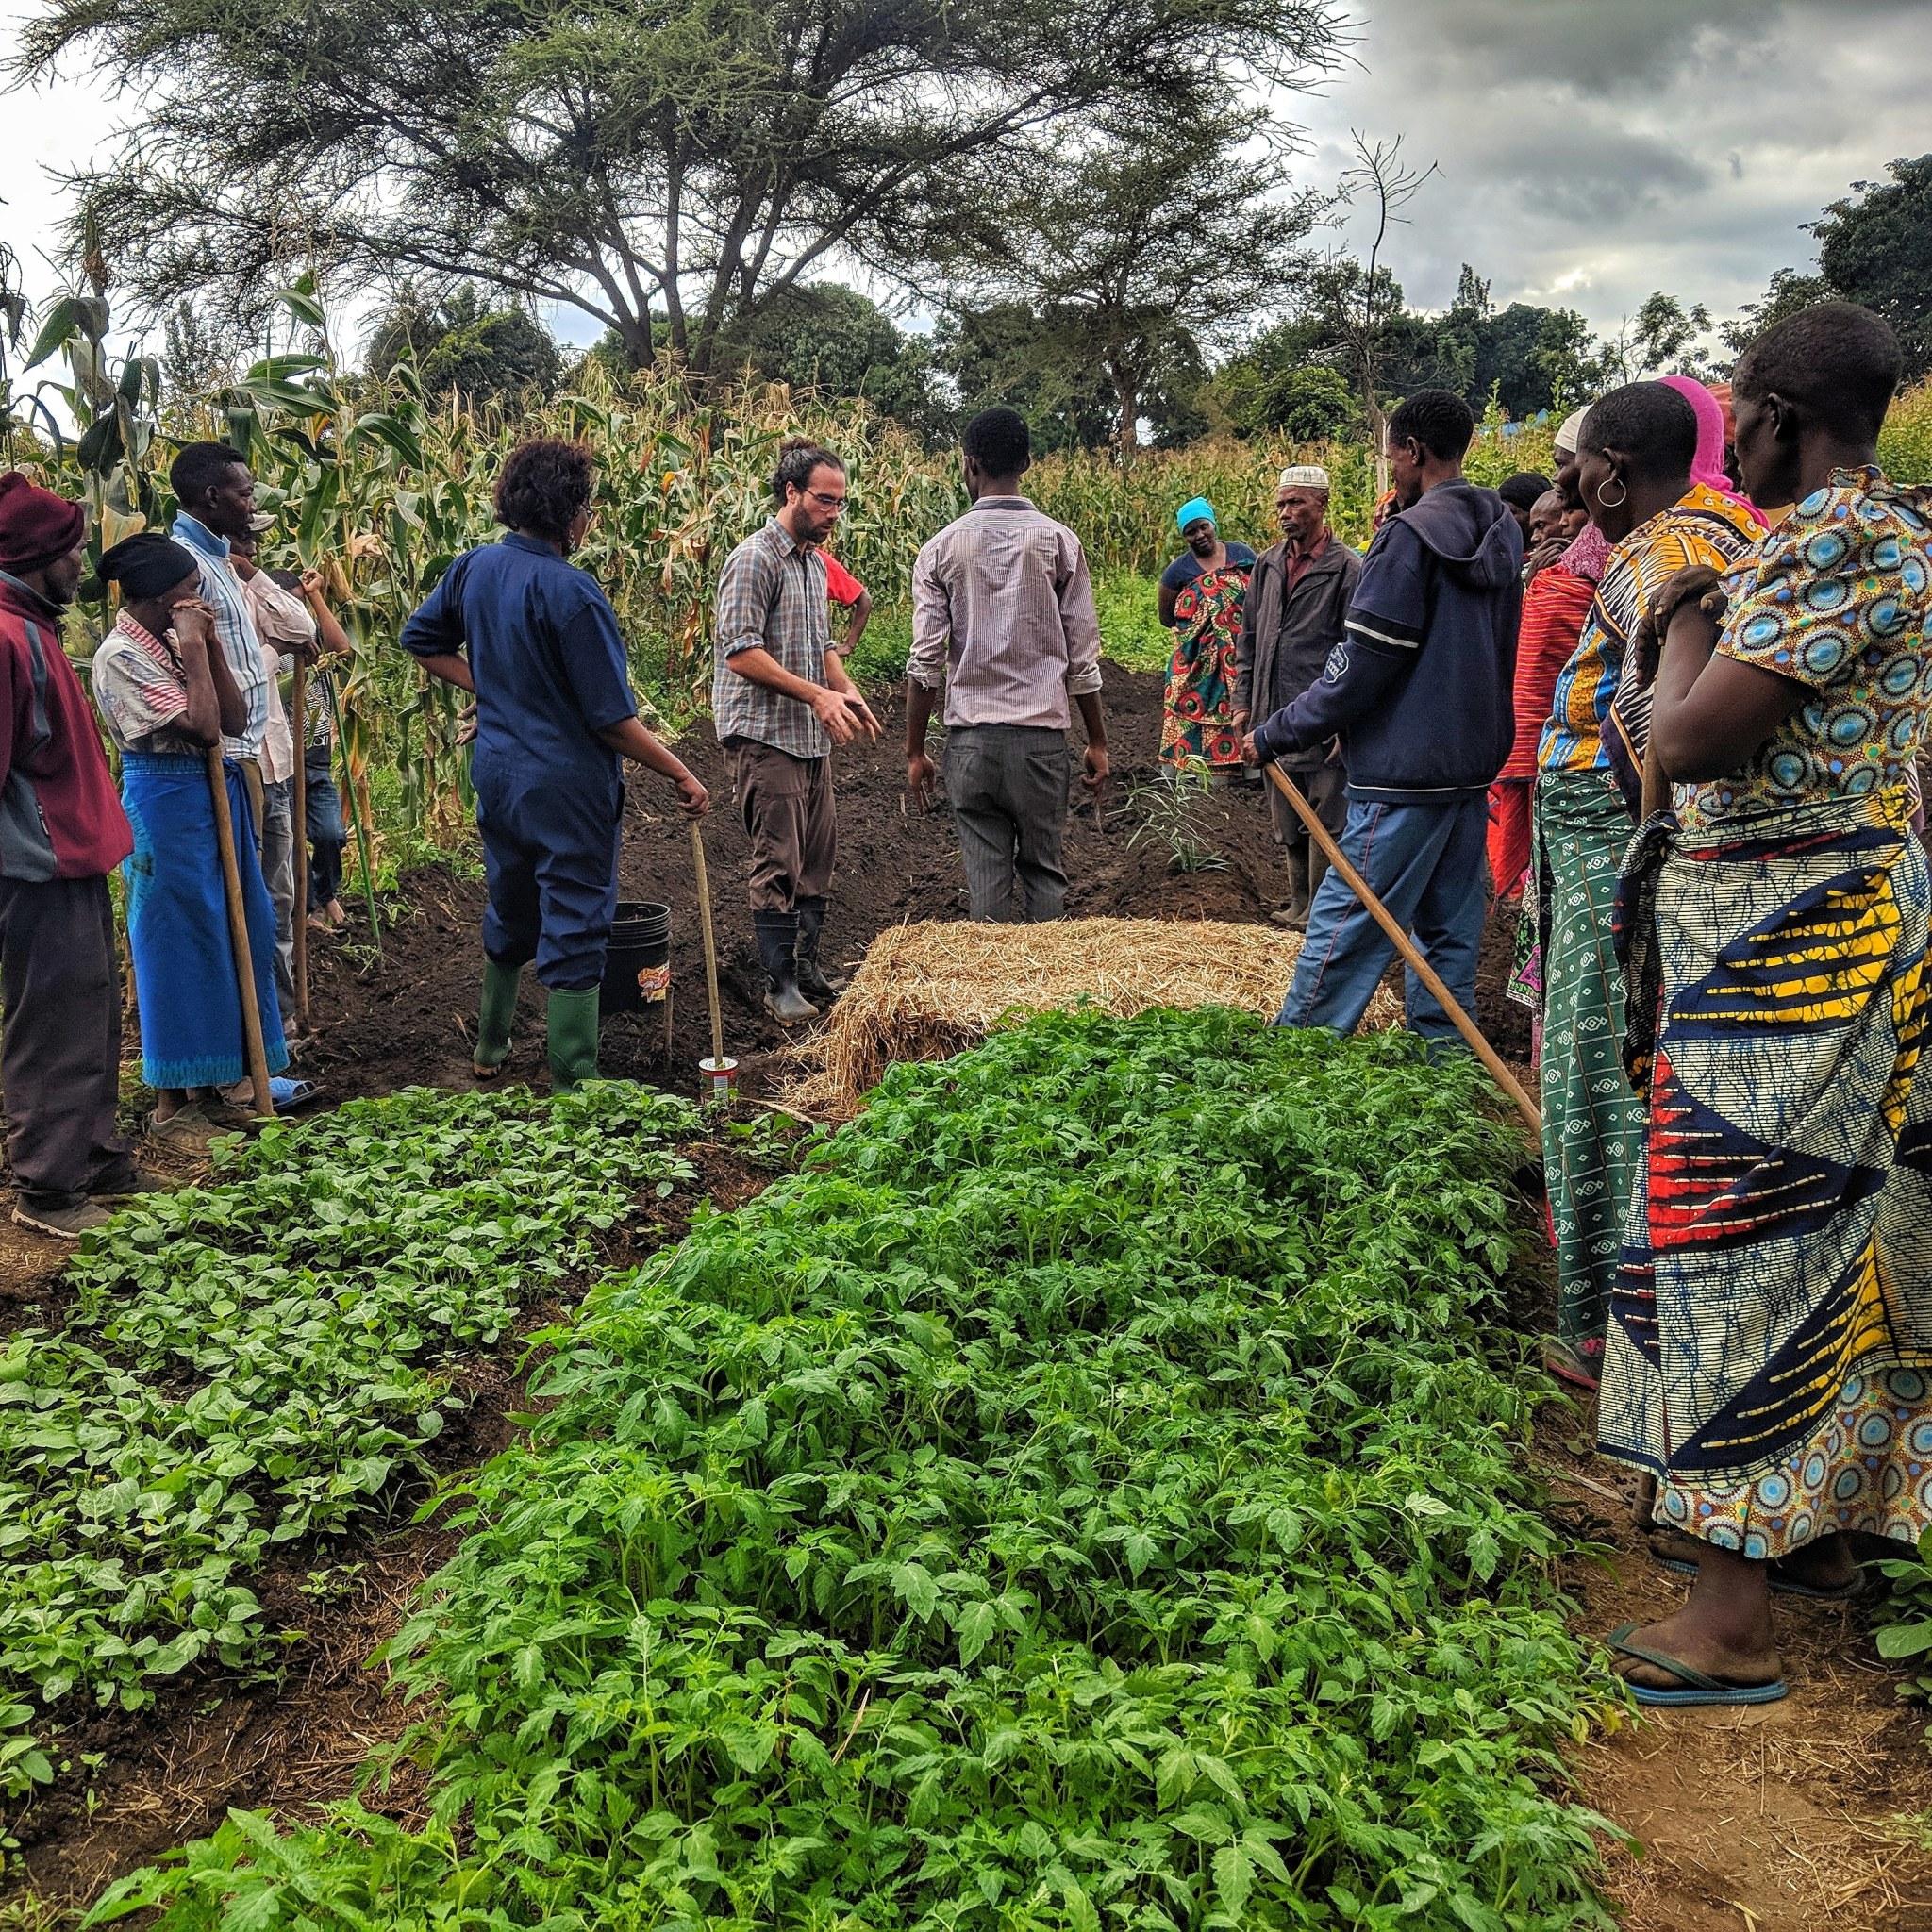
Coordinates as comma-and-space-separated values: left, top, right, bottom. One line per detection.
1600, 472, 1932, 1557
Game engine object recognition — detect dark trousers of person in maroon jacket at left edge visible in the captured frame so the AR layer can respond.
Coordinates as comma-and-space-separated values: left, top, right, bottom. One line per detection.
0, 879, 133, 1208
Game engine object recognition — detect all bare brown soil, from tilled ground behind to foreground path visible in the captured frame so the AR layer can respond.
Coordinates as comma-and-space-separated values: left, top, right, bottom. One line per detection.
0, 671, 1932, 1932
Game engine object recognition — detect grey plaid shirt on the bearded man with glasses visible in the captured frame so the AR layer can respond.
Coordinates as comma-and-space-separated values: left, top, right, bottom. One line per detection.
711, 518, 833, 758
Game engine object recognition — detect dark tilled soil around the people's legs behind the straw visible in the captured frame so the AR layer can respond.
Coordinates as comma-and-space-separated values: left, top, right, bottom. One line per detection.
301, 667, 1528, 1099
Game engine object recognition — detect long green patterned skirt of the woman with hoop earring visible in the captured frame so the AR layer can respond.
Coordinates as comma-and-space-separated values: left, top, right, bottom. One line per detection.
1536, 771, 1644, 1341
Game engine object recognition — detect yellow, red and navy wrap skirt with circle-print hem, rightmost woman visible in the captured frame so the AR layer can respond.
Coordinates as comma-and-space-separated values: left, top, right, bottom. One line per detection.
1598, 787, 1932, 1557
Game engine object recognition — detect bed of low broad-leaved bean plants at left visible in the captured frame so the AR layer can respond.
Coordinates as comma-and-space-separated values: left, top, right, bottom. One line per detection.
0, 1086, 695, 1795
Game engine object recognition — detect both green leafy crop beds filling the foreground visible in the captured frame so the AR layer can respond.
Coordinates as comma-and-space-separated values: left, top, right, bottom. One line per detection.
6, 1010, 1609, 1932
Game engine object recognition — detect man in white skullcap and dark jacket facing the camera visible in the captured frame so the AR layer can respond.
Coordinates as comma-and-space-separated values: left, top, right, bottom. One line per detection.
1233, 464, 1362, 931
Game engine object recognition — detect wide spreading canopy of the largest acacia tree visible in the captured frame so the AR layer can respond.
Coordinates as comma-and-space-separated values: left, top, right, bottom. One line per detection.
13, 0, 1337, 369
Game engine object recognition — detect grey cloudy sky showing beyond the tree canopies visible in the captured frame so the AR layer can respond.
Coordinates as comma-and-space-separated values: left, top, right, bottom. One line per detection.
0, 0, 1932, 351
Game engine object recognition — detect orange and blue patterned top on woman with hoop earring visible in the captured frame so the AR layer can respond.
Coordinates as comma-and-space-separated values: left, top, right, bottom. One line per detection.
1536, 483, 1760, 771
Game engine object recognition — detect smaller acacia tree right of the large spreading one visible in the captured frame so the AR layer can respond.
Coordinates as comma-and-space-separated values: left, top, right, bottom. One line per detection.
953, 112, 1322, 461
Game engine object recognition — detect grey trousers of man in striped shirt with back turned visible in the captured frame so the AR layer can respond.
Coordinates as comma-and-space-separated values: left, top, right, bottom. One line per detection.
944, 724, 1073, 924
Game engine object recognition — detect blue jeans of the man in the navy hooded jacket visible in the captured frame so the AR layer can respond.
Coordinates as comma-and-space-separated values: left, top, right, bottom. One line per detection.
1275, 792, 1490, 1045
